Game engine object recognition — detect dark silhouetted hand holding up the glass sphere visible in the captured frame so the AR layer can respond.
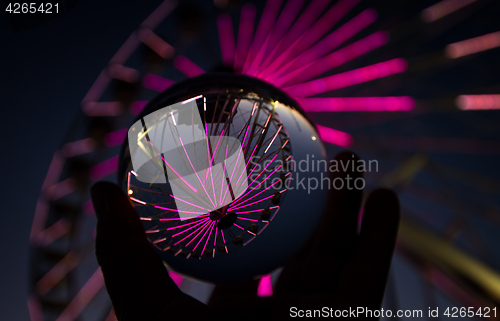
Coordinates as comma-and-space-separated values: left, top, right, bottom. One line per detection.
91, 152, 399, 321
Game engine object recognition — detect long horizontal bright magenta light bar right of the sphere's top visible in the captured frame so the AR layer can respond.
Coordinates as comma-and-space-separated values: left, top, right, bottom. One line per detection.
297, 96, 415, 112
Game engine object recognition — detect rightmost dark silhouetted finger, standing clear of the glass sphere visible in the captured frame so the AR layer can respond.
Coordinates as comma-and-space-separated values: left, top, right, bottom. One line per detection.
339, 189, 399, 309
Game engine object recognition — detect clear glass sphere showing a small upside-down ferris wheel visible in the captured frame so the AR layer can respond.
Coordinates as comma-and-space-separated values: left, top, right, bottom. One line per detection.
118, 73, 327, 283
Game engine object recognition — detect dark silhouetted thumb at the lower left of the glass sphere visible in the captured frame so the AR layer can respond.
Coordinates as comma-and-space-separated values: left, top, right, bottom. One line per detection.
90, 182, 211, 321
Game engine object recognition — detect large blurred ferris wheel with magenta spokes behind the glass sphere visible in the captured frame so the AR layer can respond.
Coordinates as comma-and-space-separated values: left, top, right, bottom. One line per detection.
29, 0, 500, 320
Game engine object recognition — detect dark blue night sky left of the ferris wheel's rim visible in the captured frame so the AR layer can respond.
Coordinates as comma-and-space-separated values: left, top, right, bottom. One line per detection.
0, 0, 161, 321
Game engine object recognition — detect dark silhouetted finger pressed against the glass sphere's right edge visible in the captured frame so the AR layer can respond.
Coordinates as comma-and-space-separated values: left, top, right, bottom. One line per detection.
302, 152, 364, 293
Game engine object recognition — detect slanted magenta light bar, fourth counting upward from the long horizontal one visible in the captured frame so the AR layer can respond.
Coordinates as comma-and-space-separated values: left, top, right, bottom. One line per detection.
267, 9, 377, 80
